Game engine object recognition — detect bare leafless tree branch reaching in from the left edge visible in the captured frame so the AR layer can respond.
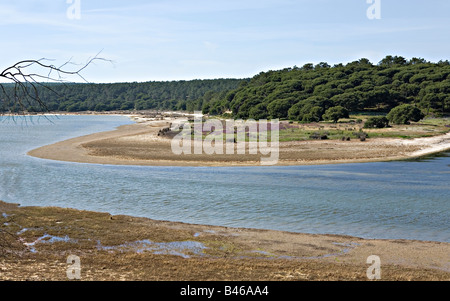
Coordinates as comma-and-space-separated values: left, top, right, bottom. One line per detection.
0, 52, 112, 114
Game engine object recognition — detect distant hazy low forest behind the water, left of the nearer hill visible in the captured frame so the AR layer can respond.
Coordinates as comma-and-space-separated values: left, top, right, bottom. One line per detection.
0, 79, 245, 113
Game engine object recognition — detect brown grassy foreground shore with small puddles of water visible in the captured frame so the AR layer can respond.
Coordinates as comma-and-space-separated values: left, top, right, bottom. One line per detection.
0, 201, 450, 281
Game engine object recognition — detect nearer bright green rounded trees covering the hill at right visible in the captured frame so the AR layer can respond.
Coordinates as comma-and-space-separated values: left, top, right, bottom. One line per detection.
203, 56, 450, 122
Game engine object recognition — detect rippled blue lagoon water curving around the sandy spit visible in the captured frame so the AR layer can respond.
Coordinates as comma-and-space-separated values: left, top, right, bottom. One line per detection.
0, 116, 450, 242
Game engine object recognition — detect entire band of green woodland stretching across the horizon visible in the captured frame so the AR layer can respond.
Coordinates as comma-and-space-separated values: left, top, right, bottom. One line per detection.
0, 56, 450, 122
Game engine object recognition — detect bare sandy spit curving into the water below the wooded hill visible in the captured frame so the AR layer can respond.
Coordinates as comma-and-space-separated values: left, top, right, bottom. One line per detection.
28, 115, 450, 166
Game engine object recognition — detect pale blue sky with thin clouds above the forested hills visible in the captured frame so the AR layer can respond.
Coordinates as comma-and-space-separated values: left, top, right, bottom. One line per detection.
0, 0, 450, 82
